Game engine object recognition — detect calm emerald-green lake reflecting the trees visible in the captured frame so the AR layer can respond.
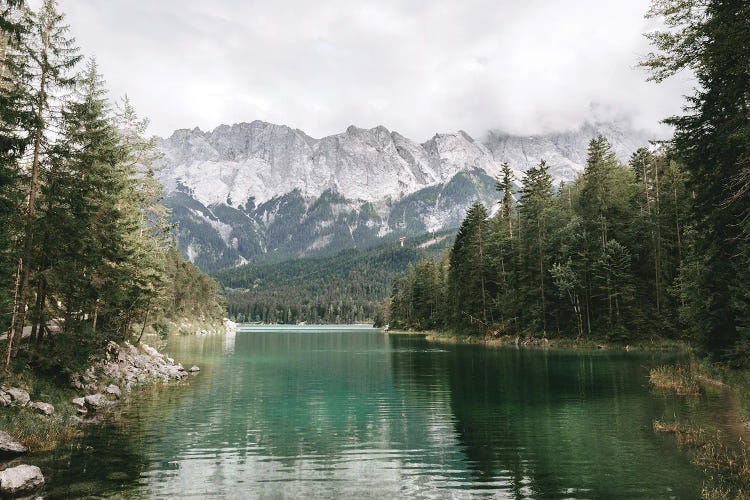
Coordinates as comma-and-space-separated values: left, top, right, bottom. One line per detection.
32, 327, 703, 498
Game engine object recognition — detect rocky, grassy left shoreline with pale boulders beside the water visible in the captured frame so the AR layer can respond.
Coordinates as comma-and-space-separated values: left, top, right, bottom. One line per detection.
0, 318, 236, 457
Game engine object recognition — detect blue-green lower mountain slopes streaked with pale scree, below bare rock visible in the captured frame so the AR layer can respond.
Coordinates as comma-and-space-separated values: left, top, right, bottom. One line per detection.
165, 169, 494, 272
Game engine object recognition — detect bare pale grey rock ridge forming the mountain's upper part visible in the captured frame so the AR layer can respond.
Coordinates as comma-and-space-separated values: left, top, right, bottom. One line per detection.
159, 120, 648, 205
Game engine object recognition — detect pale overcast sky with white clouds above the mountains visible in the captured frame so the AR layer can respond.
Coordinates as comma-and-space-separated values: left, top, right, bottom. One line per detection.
60, 0, 688, 140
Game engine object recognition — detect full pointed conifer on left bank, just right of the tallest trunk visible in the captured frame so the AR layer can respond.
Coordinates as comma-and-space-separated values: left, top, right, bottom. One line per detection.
40, 61, 127, 342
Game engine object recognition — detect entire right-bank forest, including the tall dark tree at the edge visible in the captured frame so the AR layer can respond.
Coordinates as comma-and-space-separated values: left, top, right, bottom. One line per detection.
390, 1, 750, 365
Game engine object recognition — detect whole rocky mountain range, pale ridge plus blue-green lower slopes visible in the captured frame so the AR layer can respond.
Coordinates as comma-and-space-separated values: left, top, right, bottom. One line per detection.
159, 121, 648, 270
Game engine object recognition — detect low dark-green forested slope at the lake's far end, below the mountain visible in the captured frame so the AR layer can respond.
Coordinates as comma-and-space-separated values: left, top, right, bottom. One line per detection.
216, 232, 454, 323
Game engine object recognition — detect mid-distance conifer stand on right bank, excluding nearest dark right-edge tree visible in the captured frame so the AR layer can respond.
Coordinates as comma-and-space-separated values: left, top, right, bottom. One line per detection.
390, 143, 687, 340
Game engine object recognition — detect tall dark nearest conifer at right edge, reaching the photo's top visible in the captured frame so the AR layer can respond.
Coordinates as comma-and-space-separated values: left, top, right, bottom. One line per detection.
643, 0, 750, 362
